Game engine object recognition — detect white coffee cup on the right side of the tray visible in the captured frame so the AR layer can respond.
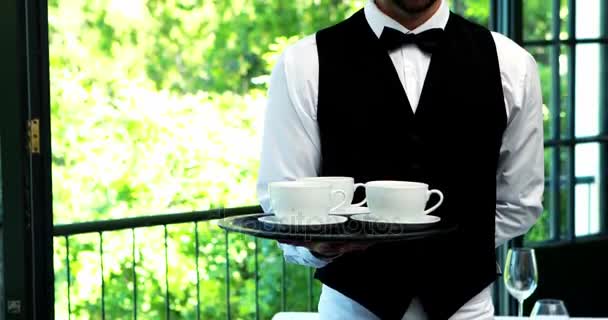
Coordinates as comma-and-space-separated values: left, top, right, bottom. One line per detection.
365, 180, 443, 218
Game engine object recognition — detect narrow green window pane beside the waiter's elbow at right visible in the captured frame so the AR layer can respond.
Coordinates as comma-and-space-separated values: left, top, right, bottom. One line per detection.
524, 148, 557, 242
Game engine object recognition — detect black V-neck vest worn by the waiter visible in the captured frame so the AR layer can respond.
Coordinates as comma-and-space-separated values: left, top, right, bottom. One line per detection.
315, 10, 506, 319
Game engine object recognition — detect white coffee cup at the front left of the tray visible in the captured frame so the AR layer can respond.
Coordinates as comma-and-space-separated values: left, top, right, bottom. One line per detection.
268, 181, 346, 217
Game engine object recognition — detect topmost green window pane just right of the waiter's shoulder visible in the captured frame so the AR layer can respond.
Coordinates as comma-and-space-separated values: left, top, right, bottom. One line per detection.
522, 0, 553, 40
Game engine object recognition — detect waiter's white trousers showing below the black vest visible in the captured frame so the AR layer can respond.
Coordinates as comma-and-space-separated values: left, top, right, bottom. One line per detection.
319, 285, 494, 320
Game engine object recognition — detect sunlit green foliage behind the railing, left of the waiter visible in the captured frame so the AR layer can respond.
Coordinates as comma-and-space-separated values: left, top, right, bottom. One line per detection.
49, 0, 362, 319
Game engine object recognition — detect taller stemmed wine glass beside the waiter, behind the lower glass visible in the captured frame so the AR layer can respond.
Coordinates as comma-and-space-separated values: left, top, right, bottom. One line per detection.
504, 248, 538, 317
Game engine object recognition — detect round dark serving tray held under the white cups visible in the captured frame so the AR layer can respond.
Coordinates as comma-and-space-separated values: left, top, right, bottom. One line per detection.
218, 214, 456, 242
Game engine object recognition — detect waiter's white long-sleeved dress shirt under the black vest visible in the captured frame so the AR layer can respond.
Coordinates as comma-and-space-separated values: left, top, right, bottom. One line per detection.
257, 0, 544, 268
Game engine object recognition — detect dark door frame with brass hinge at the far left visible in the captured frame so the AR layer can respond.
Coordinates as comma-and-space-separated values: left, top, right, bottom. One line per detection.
0, 0, 54, 319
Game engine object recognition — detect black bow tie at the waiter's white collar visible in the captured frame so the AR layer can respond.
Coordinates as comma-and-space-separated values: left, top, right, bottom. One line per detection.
380, 27, 444, 53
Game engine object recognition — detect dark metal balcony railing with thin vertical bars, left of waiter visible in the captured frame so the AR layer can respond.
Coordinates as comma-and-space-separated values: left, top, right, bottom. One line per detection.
54, 206, 315, 319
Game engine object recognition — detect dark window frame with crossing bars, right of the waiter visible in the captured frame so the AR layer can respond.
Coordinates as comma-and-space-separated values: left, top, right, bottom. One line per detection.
516, 0, 608, 247
